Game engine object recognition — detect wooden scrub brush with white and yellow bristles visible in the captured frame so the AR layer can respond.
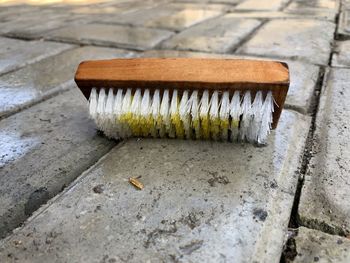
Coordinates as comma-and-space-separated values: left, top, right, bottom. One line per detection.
75, 58, 289, 144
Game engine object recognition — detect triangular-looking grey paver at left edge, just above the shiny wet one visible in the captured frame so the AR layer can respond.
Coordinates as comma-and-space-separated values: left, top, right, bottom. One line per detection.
0, 37, 73, 75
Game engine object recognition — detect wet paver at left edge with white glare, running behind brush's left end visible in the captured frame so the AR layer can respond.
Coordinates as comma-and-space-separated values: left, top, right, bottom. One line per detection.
0, 47, 133, 117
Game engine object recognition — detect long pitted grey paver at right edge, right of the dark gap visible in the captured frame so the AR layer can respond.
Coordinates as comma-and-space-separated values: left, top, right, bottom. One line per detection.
299, 69, 350, 235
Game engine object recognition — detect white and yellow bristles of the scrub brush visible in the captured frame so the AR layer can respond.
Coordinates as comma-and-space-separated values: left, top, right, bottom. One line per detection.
89, 88, 274, 144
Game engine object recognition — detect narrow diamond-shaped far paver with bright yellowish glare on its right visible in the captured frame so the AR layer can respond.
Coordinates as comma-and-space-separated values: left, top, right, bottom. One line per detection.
97, 5, 222, 31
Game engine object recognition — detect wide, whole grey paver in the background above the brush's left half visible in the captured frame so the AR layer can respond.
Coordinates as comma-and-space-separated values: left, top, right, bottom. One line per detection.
47, 23, 173, 50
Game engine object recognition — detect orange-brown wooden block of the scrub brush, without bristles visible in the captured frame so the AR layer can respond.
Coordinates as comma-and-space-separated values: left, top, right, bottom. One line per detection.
75, 58, 289, 128
